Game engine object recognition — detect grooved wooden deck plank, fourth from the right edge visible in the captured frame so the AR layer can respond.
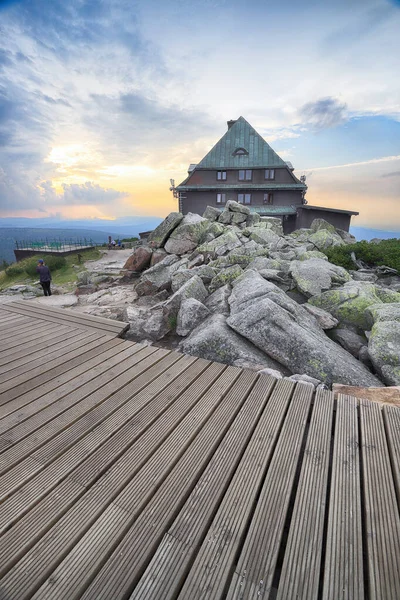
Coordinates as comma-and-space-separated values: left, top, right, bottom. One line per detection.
277, 391, 334, 600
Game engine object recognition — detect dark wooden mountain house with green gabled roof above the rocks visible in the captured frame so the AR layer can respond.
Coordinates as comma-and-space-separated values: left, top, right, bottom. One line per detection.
172, 117, 358, 233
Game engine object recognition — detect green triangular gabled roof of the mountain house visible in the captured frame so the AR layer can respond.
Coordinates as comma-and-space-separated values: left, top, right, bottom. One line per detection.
196, 117, 286, 170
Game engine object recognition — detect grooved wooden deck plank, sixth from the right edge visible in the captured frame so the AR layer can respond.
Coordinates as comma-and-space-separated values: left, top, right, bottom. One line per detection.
179, 380, 295, 600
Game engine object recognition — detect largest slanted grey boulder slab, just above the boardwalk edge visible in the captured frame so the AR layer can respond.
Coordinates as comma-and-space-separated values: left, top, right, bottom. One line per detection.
227, 271, 380, 386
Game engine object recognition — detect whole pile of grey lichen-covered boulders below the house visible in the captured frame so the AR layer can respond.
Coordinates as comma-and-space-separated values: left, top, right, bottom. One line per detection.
107, 209, 400, 387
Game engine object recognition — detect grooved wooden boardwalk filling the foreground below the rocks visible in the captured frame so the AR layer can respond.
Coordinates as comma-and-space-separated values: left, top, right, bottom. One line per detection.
0, 301, 400, 600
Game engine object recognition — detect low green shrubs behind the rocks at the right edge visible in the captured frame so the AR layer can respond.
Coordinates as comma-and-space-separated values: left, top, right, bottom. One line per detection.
324, 239, 400, 271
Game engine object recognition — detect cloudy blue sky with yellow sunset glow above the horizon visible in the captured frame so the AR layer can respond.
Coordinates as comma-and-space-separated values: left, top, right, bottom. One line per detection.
0, 0, 400, 231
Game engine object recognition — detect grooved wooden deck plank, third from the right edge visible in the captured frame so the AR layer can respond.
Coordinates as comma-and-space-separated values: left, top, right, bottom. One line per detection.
322, 394, 365, 600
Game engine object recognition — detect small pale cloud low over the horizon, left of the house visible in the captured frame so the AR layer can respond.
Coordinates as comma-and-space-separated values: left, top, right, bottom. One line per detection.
40, 181, 128, 206
